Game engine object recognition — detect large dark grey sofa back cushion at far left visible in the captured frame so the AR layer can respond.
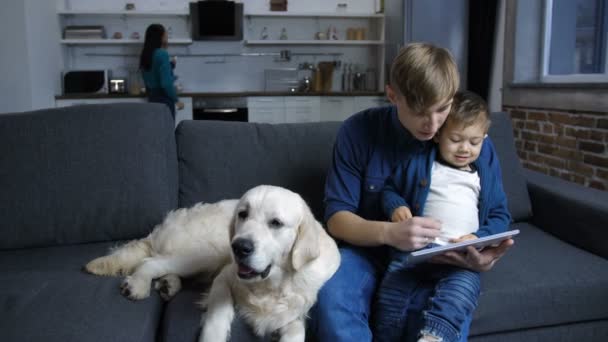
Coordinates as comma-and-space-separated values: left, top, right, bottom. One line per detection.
0, 104, 177, 249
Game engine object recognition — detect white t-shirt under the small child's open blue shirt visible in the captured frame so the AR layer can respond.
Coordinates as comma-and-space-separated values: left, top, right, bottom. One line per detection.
424, 161, 481, 245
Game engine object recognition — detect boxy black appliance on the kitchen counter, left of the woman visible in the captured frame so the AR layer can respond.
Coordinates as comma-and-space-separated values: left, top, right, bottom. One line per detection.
62, 70, 109, 94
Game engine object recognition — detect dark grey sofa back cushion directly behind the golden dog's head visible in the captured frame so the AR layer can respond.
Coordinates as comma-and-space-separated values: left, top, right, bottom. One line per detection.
176, 121, 339, 219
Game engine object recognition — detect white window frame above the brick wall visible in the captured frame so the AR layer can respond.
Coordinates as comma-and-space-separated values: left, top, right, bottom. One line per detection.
540, 0, 608, 83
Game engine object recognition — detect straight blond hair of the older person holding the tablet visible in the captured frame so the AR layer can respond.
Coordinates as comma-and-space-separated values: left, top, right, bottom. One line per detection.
390, 43, 460, 113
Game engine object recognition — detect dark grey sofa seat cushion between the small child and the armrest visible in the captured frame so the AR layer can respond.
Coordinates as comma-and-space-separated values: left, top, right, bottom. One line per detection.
471, 223, 608, 335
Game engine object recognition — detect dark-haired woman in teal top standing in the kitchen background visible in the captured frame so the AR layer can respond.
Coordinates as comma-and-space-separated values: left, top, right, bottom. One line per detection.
139, 24, 184, 119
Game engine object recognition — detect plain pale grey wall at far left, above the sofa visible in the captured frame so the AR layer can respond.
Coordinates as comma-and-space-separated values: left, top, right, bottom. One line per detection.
0, 0, 62, 113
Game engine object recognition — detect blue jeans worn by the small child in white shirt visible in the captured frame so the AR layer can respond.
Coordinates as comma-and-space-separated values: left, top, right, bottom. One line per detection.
374, 247, 480, 342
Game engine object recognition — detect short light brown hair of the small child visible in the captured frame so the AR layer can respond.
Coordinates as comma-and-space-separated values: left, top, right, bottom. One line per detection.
444, 90, 490, 132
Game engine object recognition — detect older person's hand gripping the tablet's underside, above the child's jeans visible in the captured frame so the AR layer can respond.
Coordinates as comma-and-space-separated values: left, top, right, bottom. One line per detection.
431, 239, 515, 272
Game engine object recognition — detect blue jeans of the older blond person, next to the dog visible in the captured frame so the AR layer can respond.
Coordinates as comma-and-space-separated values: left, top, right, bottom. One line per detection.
306, 245, 470, 342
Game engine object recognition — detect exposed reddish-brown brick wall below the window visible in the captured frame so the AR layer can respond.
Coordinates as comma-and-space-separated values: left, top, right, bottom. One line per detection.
503, 106, 608, 190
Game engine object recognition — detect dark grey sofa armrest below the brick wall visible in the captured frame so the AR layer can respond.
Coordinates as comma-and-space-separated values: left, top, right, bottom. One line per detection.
524, 170, 608, 259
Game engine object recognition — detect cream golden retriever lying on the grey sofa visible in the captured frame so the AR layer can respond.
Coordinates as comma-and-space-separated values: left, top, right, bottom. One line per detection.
85, 185, 340, 342
